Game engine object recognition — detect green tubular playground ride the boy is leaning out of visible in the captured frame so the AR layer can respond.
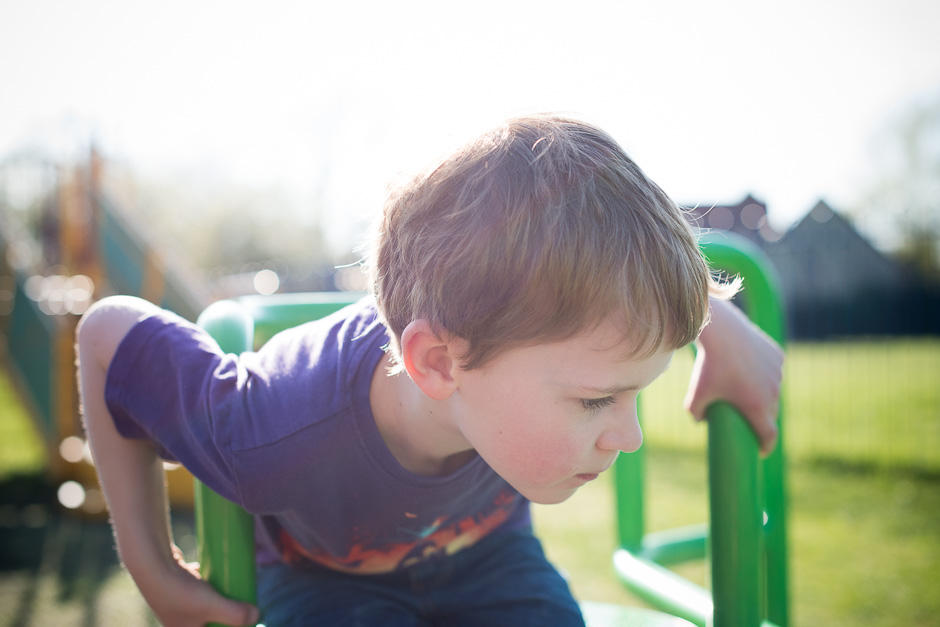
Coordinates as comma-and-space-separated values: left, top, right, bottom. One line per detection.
196, 237, 788, 627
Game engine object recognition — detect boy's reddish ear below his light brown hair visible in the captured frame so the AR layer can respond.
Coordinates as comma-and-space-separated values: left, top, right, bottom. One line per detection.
401, 319, 459, 401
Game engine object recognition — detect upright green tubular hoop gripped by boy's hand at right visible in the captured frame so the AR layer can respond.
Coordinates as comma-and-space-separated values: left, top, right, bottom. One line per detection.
702, 234, 789, 626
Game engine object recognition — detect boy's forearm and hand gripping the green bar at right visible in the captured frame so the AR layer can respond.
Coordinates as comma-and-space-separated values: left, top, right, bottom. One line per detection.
685, 299, 783, 455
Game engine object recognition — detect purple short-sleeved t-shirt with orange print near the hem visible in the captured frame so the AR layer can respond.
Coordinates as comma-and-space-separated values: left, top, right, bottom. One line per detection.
105, 300, 529, 573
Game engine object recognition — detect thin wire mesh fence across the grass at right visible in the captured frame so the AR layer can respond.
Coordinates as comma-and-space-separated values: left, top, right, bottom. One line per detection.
641, 337, 940, 474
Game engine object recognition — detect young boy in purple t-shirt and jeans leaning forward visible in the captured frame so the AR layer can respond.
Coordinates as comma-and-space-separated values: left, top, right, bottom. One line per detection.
78, 115, 782, 627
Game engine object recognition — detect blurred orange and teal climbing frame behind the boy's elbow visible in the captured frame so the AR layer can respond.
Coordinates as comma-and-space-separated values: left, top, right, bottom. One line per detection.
0, 151, 209, 515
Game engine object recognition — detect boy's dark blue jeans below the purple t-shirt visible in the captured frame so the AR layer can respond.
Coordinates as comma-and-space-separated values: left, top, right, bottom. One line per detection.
258, 531, 584, 627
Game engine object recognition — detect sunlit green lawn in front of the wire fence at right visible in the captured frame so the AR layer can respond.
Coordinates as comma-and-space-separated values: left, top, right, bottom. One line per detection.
535, 449, 940, 627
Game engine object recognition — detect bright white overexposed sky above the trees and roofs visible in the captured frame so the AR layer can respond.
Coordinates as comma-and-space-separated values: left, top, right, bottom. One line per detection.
0, 0, 940, 247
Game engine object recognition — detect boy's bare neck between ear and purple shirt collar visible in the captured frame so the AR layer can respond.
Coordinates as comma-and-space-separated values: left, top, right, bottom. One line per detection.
369, 358, 476, 476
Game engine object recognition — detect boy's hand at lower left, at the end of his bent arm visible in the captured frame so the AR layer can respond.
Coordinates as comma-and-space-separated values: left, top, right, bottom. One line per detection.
132, 546, 259, 627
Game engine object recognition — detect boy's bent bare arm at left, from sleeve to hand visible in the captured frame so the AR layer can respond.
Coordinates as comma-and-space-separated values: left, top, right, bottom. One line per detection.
77, 297, 258, 625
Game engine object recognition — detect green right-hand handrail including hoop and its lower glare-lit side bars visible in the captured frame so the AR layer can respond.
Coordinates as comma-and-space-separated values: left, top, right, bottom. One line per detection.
614, 234, 789, 627
